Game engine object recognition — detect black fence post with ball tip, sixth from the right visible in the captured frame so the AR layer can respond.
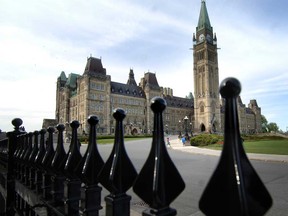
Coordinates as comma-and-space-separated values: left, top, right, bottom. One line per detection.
51, 124, 67, 206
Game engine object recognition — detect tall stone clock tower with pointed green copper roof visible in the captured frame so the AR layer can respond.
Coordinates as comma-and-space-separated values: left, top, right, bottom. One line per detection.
193, 0, 221, 132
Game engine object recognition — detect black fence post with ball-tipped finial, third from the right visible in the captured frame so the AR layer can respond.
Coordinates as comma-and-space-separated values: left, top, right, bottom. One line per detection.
99, 109, 137, 216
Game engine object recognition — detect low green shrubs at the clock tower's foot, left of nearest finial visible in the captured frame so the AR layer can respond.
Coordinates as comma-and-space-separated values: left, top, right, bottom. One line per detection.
190, 134, 223, 146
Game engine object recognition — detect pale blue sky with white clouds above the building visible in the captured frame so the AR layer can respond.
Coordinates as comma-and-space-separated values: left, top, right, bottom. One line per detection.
0, 0, 288, 131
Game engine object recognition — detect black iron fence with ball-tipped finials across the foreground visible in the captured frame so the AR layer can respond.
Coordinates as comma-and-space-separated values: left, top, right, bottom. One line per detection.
0, 78, 272, 216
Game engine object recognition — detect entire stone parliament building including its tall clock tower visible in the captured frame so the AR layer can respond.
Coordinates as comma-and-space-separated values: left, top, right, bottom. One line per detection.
56, 0, 261, 134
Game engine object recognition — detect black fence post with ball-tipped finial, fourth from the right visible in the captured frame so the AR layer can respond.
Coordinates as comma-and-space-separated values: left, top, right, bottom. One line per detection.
81, 116, 104, 216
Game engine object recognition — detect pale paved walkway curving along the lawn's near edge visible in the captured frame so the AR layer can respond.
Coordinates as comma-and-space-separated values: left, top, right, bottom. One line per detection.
170, 136, 288, 163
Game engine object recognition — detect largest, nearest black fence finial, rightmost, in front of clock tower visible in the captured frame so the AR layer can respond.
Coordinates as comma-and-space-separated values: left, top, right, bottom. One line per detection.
199, 78, 272, 216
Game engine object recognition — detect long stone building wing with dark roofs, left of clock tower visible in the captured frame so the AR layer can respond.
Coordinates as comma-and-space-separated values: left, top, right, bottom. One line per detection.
56, 57, 193, 134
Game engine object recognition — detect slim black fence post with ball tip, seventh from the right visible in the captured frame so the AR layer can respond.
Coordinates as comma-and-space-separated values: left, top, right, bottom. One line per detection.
42, 127, 55, 200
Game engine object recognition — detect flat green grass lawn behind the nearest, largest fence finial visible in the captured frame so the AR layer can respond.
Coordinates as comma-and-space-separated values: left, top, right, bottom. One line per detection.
205, 140, 288, 155
